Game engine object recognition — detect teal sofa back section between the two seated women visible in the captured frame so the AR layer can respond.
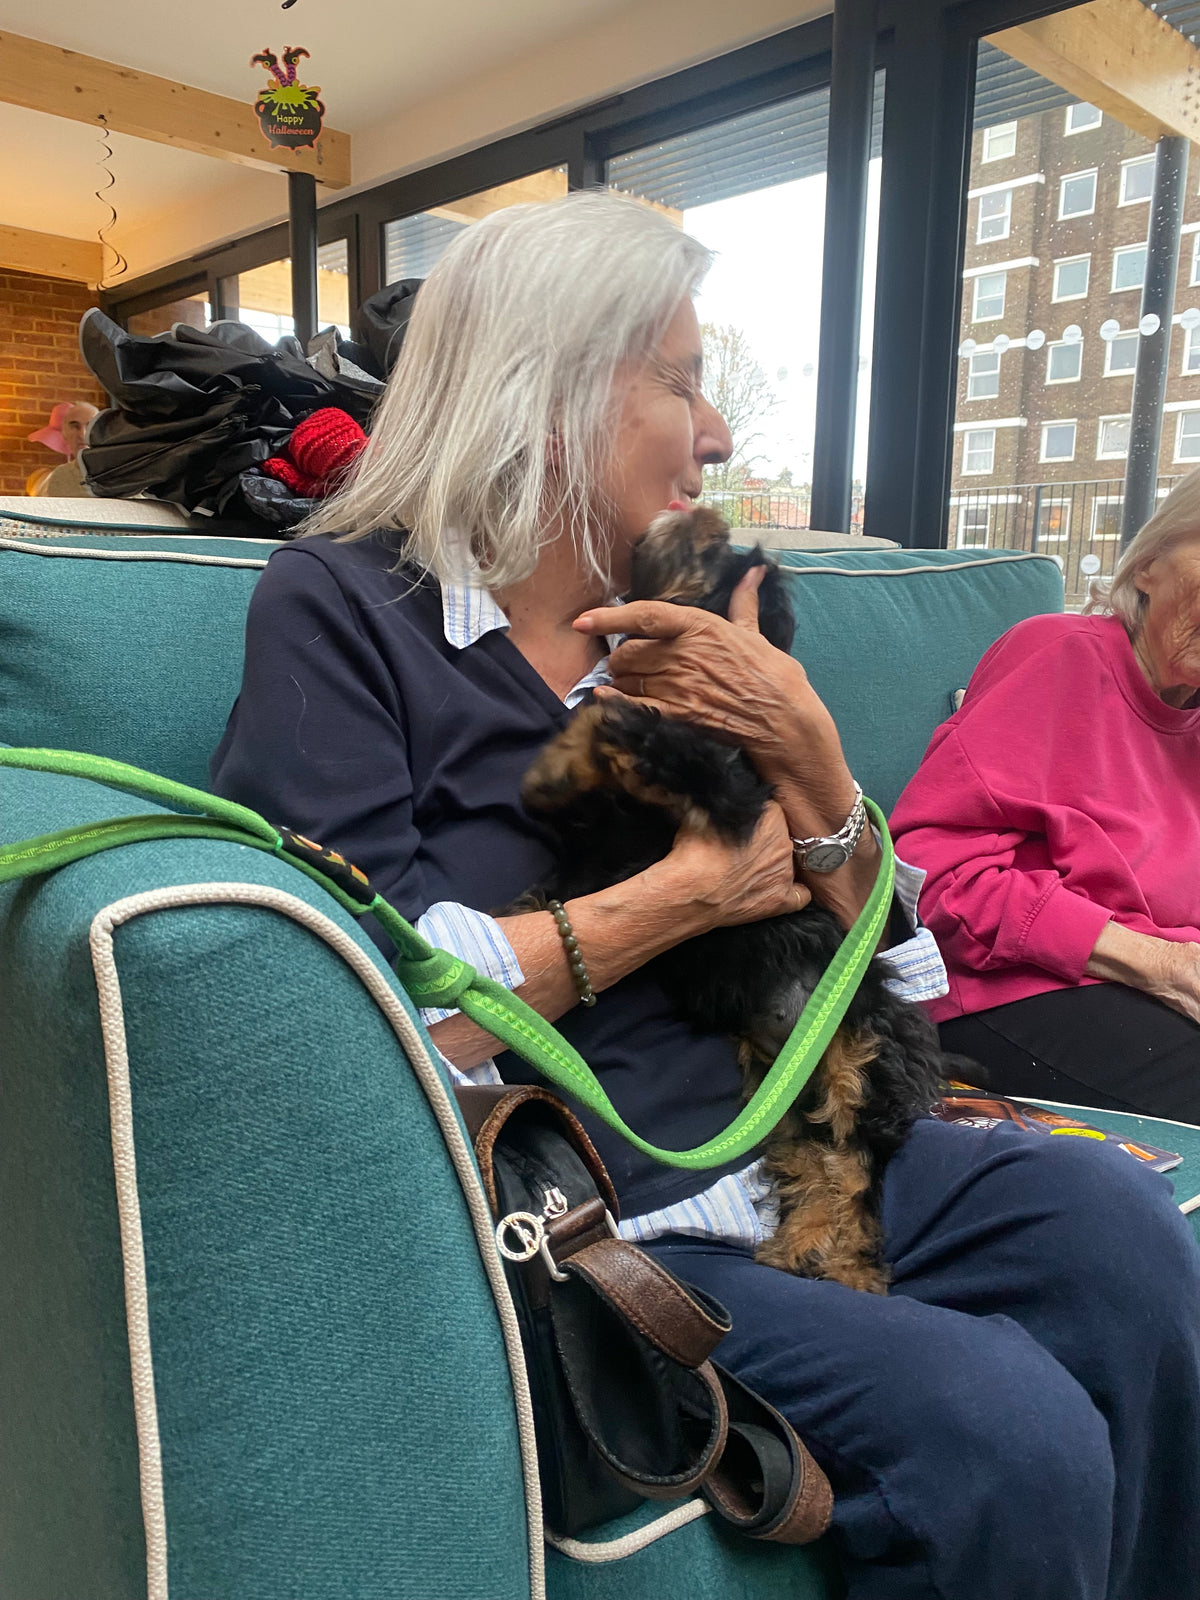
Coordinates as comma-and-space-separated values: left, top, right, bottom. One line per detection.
779, 550, 1062, 811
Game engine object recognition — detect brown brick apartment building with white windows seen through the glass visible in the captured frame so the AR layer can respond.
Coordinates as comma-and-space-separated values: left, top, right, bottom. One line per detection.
949, 106, 1200, 576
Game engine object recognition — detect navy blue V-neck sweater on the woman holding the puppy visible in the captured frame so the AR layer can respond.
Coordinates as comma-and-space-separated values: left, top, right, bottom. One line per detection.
211, 538, 744, 1216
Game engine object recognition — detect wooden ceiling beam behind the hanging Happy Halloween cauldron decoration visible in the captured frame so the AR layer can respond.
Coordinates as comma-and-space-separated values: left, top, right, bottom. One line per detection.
0, 32, 350, 189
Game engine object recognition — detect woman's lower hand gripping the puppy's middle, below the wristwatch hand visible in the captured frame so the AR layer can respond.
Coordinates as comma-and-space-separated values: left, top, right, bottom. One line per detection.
643, 802, 813, 938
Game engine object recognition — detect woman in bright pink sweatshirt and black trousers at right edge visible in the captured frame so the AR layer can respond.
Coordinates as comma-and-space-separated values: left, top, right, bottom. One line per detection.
891, 472, 1200, 1123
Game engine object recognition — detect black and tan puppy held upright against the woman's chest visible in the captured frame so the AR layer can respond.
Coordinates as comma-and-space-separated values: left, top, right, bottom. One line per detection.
522, 509, 944, 1293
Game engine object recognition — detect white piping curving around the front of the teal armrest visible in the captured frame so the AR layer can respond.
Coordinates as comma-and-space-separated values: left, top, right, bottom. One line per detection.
90, 883, 544, 1600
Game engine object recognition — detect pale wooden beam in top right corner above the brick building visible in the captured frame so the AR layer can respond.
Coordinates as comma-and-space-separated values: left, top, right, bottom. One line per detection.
989, 0, 1200, 144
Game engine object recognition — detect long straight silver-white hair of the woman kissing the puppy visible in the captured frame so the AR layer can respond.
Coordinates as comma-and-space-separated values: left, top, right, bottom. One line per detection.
304, 190, 712, 589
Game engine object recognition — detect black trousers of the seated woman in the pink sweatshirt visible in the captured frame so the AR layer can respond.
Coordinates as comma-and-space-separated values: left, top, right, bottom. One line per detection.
939, 984, 1200, 1123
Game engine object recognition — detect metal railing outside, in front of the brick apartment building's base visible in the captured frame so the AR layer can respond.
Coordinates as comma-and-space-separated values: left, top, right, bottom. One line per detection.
946, 477, 1179, 610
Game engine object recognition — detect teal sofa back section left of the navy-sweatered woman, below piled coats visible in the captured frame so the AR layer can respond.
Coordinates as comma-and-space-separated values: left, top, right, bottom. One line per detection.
0, 533, 275, 789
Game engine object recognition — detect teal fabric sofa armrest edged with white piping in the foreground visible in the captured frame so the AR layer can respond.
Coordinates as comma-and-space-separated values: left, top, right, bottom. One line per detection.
0, 771, 528, 1600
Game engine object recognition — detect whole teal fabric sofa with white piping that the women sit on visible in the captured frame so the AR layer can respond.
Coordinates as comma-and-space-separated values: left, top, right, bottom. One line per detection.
0, 510, 1200, 1600
